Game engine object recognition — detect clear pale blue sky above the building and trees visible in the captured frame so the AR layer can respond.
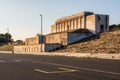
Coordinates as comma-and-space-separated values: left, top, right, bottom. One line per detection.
0, 0, 120, 40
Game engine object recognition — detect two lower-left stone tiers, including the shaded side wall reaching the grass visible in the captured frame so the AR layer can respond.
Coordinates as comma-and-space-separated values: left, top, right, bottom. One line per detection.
14, 34, 61, 54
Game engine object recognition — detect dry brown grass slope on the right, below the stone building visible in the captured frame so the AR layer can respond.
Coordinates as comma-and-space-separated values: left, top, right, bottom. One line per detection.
58, 30, 120, 53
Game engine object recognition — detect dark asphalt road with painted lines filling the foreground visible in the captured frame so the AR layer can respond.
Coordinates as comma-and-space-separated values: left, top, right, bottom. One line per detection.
0, 54, 120, 80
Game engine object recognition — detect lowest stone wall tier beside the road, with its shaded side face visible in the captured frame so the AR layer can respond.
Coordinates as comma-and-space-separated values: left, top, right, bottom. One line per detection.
14, 43, 62, 54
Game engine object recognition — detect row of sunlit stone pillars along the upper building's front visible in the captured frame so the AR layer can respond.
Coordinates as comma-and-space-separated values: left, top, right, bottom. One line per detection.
55, 16, 86, 32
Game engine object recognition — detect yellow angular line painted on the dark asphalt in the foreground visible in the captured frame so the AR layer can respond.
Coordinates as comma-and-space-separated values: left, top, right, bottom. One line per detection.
34, 68, 77, 74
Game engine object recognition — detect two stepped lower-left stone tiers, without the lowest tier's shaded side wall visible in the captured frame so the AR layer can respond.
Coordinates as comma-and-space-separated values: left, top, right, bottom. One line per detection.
14, 34, 45, 53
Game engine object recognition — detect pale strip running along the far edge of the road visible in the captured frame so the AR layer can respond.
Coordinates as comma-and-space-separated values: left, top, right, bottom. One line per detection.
0, 51, 120, 60
